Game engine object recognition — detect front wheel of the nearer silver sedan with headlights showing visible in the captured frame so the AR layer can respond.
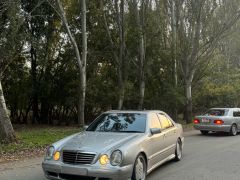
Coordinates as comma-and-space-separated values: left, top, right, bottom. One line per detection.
132, 154, 147, 180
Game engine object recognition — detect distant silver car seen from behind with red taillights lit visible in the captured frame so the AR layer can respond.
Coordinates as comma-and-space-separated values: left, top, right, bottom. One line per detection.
193, 108, 240, 136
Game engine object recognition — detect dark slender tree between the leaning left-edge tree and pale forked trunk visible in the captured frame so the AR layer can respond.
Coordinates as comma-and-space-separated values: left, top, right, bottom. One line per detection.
21, 0, 55, 124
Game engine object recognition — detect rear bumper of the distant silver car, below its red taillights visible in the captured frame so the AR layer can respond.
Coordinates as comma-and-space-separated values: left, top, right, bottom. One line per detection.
194, 124, 231, 132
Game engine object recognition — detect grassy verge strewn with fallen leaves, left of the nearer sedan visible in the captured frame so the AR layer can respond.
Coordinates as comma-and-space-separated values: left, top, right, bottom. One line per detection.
0, 126, 81, 162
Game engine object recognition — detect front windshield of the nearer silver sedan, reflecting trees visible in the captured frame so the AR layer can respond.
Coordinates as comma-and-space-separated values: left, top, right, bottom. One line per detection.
86, 113, 147, 133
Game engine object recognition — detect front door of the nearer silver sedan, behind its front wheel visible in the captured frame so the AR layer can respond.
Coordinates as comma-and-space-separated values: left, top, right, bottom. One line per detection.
147, 113, 166, 169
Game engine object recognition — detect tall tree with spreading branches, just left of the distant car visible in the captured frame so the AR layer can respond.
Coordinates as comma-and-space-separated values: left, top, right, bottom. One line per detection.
178, 0, 239, 123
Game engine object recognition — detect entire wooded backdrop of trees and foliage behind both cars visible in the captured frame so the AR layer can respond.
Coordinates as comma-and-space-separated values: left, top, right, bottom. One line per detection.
0, 0, 240, 143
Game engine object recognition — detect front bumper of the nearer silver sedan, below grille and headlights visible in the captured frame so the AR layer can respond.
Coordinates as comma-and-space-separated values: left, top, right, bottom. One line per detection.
42, 161, 133, 180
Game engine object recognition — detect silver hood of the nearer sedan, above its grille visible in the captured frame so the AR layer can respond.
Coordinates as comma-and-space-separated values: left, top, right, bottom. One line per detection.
62, 131, 141, 153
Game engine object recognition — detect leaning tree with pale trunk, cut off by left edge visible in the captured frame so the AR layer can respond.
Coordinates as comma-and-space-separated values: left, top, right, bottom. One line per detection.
0, 1, 21, 143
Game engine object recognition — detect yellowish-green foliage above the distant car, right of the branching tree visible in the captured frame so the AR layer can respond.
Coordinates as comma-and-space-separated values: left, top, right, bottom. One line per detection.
194, 31, 240, 111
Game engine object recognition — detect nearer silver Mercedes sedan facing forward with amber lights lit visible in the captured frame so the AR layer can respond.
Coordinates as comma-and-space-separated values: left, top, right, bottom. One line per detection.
42, 111, 184, 180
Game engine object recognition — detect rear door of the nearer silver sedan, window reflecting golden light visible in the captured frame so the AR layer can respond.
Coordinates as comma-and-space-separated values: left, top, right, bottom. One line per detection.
158, 113, 177, 157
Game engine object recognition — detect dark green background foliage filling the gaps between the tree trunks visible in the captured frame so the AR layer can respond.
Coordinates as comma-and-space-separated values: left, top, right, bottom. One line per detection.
0, 0, 240, 125
